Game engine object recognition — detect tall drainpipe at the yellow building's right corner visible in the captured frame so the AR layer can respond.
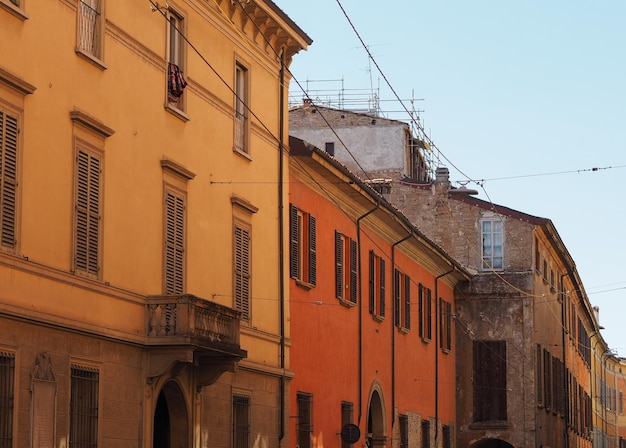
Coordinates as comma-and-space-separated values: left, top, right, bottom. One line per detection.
278, 50, 285, 444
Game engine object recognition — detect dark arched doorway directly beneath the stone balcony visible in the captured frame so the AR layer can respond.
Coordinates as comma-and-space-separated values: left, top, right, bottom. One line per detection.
152, 381, 190, 448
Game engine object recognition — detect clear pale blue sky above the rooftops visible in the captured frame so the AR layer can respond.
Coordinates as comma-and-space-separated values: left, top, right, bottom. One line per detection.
275, 0, 626, 357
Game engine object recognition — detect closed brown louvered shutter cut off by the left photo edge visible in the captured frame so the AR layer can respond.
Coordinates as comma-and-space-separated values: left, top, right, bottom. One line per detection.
0, 111, 18, 248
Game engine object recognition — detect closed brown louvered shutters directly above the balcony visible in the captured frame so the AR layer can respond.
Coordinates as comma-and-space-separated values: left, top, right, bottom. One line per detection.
165, 191, 185, 294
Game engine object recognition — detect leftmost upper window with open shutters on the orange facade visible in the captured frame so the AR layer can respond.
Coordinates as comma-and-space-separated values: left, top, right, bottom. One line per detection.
289, 204, 317, 286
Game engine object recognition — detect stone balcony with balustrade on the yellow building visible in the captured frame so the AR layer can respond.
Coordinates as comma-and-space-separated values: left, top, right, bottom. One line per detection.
146, 294, 247, 385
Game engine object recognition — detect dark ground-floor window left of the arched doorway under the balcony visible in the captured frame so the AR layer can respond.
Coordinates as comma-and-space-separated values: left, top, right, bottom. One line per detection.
69, 365, 99, 448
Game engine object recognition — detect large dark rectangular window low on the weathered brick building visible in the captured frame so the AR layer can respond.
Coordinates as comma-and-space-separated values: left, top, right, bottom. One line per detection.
473, 340, 507, 422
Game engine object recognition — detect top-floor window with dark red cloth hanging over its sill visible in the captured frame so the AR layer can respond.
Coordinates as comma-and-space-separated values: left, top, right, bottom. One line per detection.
167, 8, 187, 110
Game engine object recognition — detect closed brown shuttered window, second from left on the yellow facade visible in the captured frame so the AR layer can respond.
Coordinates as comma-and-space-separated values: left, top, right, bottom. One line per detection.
74, 149, 101, 277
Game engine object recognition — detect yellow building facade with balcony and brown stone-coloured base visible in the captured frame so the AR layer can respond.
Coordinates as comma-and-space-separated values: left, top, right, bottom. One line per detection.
0, 0, 311, 448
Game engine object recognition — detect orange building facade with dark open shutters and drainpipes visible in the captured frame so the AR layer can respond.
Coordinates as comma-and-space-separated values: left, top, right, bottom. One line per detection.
289, 138, 468, 448
